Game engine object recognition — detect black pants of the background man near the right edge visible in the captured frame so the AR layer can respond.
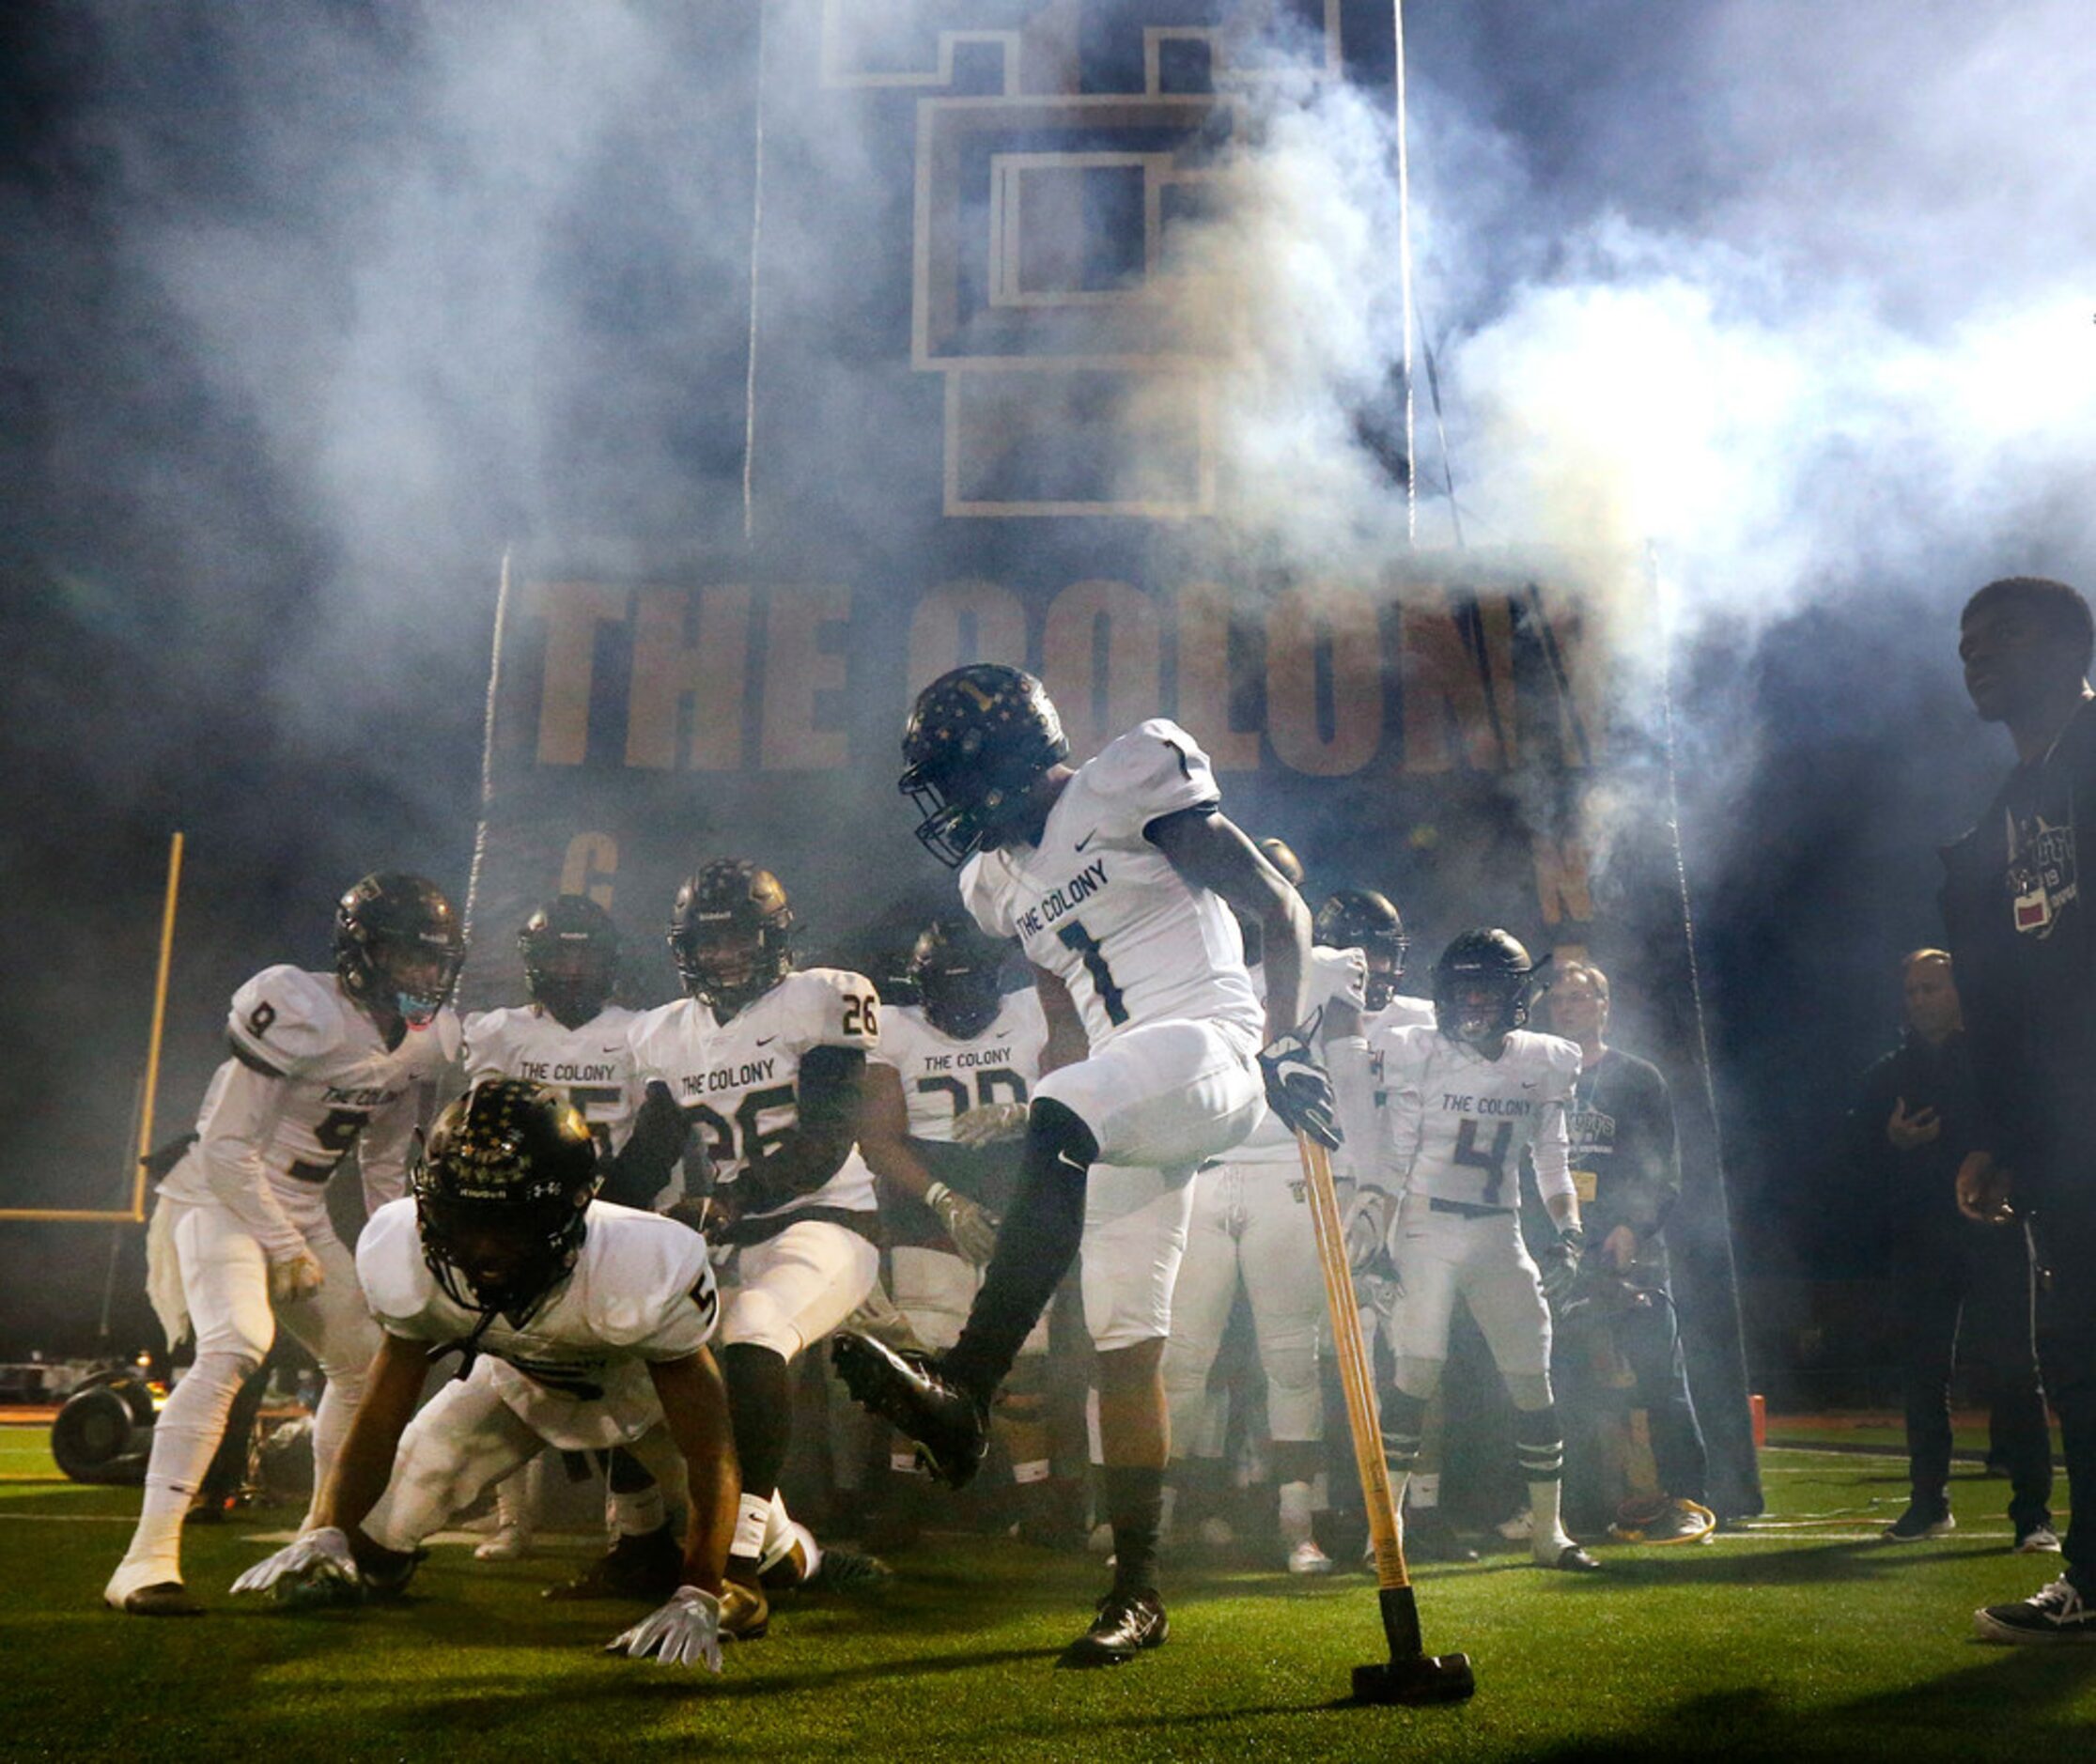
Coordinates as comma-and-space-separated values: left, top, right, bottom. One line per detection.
1897, 1224, 2052, 1534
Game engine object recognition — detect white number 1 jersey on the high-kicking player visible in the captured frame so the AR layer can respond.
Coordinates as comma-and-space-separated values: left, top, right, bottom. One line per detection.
960, 717, 1266, 1054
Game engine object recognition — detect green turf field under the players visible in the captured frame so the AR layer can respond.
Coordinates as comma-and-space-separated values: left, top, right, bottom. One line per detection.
0, 1427, 2096, 1764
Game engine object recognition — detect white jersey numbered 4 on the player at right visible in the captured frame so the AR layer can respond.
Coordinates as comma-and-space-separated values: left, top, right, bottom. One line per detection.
1369, 1025, 1580, 1207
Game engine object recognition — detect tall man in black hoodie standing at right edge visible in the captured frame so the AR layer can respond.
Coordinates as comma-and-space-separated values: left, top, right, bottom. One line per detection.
1943, 576, 2096, 1643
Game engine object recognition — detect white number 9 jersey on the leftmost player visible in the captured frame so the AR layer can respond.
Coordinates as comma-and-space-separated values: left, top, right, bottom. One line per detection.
162, 967, 459, 1202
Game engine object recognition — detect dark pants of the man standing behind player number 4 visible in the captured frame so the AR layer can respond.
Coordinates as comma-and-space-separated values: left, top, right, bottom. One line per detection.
1551, 1284, 1708, 1524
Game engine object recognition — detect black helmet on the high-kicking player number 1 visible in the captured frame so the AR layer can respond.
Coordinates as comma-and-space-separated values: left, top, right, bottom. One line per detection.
897, 662, 1069, 870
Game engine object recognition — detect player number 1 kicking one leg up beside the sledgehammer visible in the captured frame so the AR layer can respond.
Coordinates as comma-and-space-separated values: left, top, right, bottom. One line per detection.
836, 662, 1337, 1665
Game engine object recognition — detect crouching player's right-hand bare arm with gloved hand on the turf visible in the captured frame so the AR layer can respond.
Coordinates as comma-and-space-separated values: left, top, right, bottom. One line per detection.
606, 1347, 742, 1672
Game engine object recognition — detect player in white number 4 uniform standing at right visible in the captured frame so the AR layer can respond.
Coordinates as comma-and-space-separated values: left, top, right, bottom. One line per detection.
1348, 930, 1599, 1571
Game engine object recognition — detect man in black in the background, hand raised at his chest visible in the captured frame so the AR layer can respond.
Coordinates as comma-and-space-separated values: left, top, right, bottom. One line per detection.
1851, 949, 2060, 1555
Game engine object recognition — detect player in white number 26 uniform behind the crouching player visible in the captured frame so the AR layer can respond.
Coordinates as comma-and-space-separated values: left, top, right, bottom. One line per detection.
633, 857, 882, 1586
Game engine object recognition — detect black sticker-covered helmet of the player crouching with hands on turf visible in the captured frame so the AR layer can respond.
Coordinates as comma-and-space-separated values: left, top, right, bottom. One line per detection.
409, 1079, 598, 1328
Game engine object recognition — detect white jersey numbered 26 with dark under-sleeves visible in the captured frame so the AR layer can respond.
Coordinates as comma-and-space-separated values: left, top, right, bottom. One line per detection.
633, 967, 880, 1219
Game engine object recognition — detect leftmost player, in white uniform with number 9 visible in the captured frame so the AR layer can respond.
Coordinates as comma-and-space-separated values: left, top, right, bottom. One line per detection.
102, 874, 465, 1617
